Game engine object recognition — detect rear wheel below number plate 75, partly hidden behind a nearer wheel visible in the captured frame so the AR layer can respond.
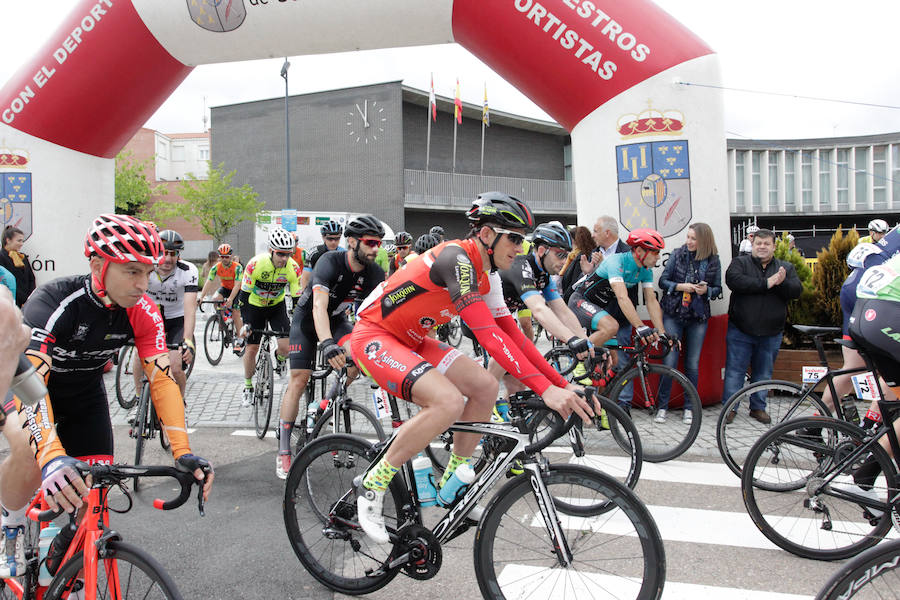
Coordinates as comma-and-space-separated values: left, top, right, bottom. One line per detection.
716, 380, 831, 477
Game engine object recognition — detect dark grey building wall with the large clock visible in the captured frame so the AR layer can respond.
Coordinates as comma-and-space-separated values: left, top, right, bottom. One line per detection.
211, 82, 403, 257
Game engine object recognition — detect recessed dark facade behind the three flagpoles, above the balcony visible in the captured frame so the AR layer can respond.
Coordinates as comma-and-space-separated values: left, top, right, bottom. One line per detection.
403, 102, 566, 179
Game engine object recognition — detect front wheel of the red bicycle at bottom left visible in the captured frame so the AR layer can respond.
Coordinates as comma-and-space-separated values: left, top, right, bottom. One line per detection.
44, 541, 181, 600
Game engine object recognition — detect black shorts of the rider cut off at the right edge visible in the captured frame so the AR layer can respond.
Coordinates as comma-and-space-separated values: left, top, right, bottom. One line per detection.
850, 298, 900, 387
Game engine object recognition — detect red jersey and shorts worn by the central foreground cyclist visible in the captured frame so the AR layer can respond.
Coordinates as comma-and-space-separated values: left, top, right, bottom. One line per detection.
351, 239, 566, 399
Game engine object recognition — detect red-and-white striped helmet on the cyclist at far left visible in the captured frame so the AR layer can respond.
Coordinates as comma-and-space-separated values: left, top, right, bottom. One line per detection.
84, 214, 163, 265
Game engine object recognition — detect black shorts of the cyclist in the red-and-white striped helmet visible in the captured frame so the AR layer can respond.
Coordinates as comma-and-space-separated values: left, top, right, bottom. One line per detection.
47, 375, 113, 456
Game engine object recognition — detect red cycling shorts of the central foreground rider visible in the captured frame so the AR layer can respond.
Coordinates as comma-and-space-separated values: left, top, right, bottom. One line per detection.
350, 321, 463, 401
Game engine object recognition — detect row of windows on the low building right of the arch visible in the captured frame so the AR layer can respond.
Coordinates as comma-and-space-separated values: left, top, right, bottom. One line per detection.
733, 144, 900, 212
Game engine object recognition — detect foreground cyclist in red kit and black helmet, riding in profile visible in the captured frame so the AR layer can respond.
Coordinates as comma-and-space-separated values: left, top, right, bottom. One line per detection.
350, 192, 593, 543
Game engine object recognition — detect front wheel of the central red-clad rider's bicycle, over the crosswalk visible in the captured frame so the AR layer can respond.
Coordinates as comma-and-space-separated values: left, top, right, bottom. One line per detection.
474, 464, 666, 600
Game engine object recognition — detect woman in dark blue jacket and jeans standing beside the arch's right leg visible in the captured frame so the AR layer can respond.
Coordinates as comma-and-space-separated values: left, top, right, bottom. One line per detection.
655, 223, 722, 424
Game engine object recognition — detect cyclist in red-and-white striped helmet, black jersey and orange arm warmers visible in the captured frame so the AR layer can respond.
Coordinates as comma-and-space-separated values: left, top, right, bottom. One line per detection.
12, 215, 213, 511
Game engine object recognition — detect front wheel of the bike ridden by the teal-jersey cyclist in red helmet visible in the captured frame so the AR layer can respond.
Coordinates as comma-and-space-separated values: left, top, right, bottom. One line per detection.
609, 364, 703, 462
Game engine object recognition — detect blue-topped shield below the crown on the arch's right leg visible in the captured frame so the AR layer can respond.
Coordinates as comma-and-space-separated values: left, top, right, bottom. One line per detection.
616, 140, 691, 237
